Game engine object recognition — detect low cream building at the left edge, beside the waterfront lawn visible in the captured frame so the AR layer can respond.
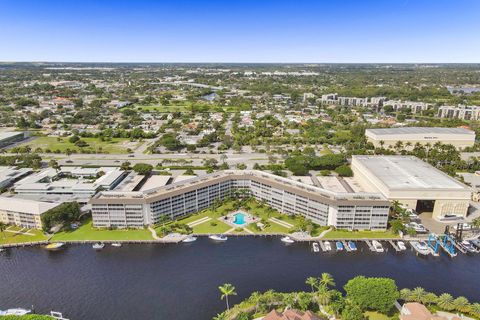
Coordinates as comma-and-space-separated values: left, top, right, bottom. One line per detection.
0, 197, 59, 229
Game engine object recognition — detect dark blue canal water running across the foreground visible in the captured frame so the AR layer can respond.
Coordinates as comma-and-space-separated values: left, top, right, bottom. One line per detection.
0, 237, 480, 320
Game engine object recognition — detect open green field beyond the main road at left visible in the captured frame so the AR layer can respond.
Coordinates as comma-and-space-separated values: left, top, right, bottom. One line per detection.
20, 137, 139, 153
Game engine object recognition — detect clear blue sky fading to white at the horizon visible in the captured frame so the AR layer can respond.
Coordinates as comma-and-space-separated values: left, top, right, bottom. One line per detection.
0, 0, 480, 62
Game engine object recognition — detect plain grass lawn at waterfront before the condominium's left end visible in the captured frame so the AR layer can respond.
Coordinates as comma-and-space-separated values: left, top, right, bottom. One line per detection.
51, 221, 153, 241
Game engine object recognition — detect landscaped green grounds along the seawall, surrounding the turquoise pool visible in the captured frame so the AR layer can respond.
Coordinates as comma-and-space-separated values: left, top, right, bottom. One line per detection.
0, 197, 398, 246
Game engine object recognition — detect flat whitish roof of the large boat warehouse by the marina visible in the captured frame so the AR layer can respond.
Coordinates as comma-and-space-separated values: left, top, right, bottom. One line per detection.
352, 155, 469, 191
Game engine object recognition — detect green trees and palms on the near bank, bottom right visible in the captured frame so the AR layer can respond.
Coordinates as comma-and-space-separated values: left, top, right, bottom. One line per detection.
213, 273, 480, 320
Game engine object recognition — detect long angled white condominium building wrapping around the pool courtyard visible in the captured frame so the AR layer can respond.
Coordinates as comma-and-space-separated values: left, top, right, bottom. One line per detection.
90, 170, 389, 230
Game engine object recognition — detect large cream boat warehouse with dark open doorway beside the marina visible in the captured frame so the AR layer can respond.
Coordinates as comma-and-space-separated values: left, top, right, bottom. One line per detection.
352, 155, 472, 218
